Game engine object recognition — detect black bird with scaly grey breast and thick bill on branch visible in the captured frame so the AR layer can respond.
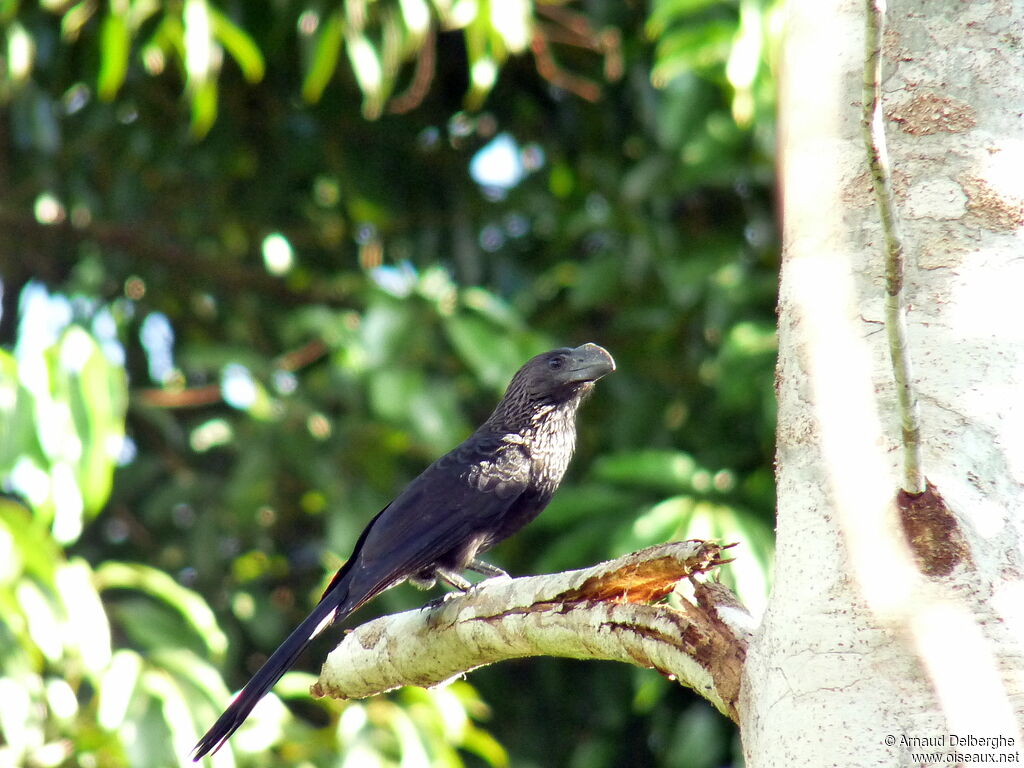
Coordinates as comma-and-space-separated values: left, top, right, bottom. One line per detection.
193, 344, 615, 761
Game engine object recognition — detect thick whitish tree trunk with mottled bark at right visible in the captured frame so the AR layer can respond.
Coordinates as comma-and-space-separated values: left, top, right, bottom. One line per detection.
739, 0, 1024, 767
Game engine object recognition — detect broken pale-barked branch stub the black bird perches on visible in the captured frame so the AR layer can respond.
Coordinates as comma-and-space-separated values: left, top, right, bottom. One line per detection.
311, 541, 750, 721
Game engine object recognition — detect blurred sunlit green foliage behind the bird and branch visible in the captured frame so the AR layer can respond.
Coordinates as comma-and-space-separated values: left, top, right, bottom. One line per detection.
0, 0, 777, 768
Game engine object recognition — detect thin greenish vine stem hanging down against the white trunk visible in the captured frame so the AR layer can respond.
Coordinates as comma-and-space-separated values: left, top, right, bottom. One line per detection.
862, 0, 926, 496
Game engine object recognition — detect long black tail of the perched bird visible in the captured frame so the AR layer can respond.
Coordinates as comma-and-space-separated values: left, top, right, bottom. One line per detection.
193, 580, 352, 762
